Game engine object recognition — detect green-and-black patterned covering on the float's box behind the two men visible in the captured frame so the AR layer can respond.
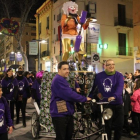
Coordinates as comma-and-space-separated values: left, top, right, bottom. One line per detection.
38, 72, 95, 132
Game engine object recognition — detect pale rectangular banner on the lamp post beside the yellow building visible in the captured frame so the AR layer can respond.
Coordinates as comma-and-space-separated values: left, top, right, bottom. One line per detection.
29, 42, 38, 55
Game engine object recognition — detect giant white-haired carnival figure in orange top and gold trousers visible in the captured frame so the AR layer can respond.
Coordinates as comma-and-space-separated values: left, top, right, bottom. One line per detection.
61, 1, 90, 64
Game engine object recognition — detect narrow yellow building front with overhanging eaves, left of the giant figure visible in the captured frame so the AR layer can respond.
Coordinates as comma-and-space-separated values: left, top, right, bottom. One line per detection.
35, 0, 53, 71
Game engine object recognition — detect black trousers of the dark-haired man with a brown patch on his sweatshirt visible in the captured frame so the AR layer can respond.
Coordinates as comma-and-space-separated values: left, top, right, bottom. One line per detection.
52, 116, 74, 140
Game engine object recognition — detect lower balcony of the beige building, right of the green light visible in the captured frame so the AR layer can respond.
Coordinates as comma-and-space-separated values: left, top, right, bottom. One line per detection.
116, 47, 133, 56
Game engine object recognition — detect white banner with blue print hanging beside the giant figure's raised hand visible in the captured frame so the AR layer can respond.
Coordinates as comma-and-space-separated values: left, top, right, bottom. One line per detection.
87, 23, 100, 44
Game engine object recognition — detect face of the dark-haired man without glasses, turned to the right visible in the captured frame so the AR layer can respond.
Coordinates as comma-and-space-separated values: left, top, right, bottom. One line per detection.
58, 65, 69, 77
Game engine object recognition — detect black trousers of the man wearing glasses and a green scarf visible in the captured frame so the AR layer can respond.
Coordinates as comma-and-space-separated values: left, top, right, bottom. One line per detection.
105, 105, 124, 140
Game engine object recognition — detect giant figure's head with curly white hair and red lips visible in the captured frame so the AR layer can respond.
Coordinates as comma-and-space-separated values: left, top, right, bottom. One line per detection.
62, 1, 78, 16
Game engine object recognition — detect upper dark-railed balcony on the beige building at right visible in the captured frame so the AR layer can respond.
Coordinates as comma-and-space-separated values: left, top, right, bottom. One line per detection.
114, 17, 133, 28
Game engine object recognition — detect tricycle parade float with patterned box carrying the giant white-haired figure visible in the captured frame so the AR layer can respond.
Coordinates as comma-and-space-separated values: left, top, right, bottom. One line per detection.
32, 1, 112, 139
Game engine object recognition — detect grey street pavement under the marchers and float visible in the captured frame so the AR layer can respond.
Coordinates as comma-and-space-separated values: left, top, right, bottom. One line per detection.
8, 103, 140, 140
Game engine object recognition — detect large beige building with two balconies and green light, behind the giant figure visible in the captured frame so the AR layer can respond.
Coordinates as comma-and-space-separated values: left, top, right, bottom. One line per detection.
36, 0, 134, 73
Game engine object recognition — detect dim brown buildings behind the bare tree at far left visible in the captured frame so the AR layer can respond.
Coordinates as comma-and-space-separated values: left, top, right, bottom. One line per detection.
0, 18, 36, 71
